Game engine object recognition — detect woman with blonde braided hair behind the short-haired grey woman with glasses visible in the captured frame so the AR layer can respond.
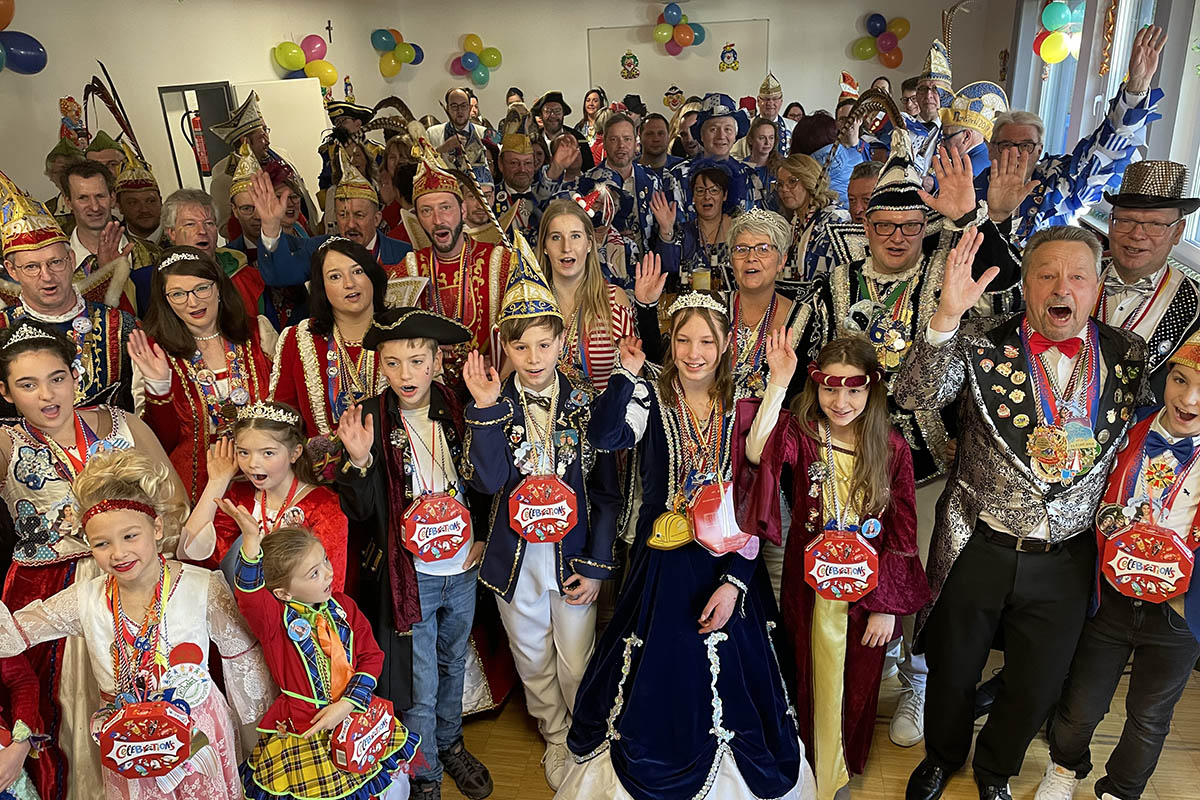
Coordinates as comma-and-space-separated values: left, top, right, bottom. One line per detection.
775, 154, 851, 281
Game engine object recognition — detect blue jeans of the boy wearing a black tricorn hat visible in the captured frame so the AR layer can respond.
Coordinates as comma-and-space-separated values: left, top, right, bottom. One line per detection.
404, 569, 479, 781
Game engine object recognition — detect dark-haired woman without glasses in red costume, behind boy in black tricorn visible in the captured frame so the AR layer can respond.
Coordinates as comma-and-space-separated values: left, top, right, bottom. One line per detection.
270, 236, 388, 438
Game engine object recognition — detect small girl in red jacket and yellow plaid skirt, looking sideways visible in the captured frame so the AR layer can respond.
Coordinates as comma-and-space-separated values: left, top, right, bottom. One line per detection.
229, 513, 420, 800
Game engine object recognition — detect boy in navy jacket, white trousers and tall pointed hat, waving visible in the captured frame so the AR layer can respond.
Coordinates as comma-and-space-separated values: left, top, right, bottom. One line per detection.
463, 254, 622, 789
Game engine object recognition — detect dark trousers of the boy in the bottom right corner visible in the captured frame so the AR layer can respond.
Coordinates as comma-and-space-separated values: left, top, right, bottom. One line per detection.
1050, 581, 1200, 800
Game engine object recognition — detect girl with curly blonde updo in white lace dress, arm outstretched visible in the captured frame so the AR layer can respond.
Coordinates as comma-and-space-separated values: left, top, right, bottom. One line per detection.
0, 450, 274, 800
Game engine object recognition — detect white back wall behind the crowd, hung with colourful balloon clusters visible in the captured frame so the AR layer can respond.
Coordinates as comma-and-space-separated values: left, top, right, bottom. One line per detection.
0, 0, 1012, 197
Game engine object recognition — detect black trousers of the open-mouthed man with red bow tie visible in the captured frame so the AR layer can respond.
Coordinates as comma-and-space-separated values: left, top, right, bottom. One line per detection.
922, 528, 1096, 786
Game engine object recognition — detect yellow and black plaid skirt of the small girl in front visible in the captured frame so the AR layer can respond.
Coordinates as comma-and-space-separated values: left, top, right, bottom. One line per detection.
241, 720, 421, 800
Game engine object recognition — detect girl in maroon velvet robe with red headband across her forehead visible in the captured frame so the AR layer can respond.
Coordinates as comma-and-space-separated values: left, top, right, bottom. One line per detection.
746, 336, 929, 800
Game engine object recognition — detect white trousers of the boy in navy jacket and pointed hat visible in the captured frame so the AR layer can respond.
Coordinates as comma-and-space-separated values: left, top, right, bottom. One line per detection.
496, 543, 596, 745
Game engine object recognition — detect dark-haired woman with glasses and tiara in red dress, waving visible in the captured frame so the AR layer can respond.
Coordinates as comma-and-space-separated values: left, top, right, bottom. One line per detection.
128, 246, 278, 503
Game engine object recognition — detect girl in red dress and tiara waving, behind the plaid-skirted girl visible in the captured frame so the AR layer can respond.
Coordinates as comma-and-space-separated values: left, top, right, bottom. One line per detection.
180, 402, 347, 591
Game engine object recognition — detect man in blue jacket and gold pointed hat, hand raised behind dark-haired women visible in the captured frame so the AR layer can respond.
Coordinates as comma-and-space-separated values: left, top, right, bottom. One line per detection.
250, 149, 413, 292
